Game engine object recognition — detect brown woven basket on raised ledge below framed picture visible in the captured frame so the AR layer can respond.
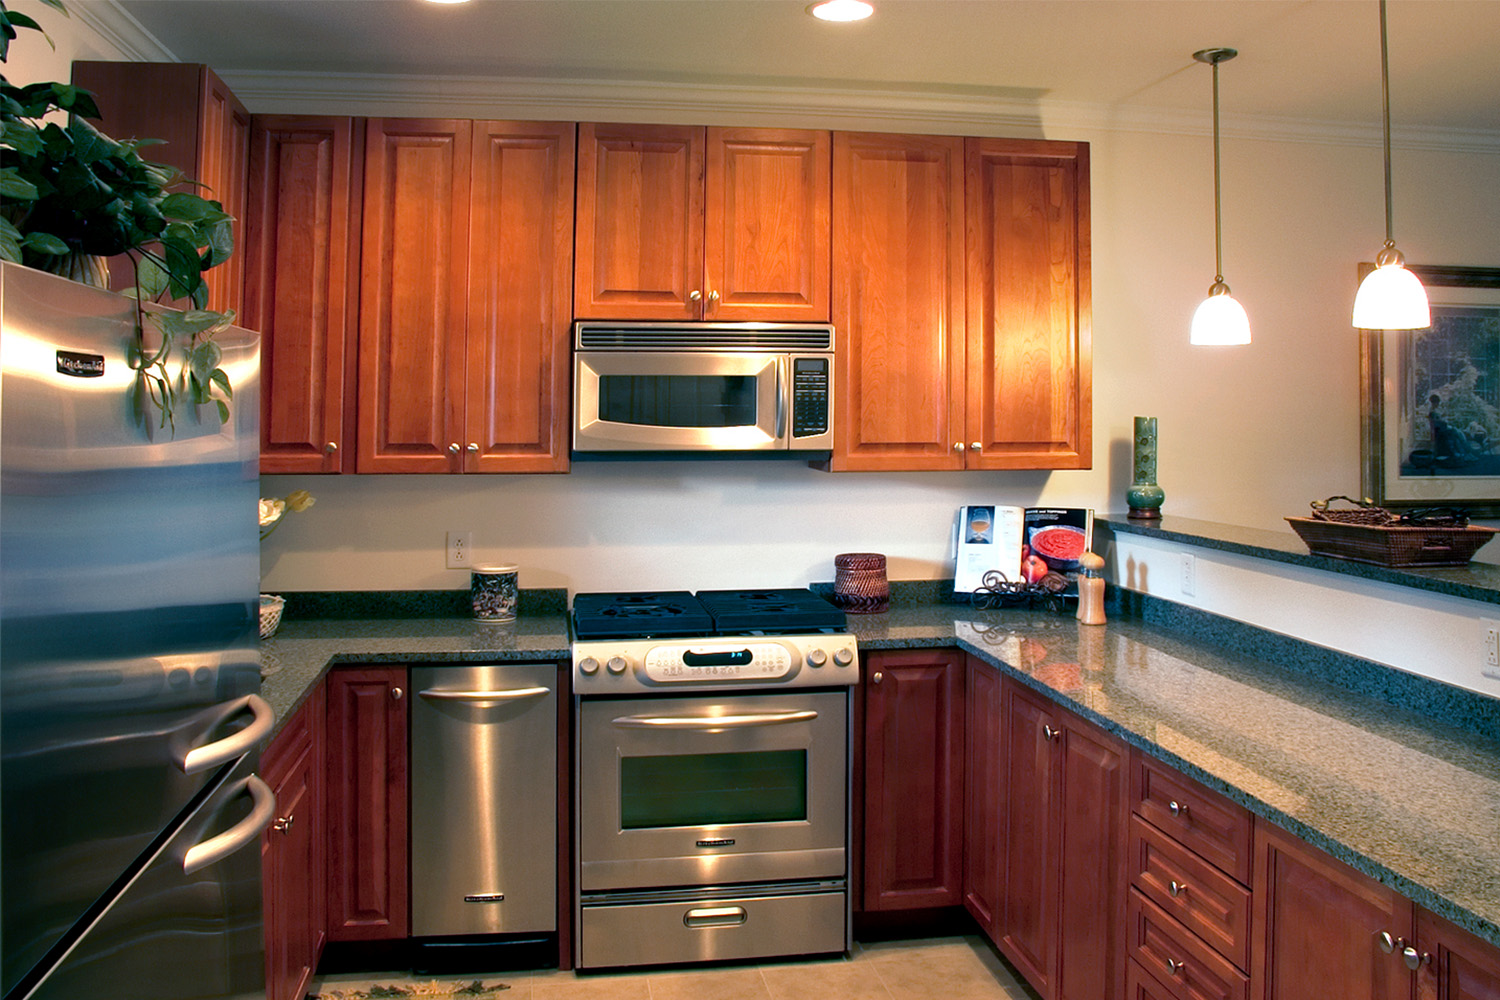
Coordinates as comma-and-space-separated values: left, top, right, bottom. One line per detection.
1287, 496, 1496, 568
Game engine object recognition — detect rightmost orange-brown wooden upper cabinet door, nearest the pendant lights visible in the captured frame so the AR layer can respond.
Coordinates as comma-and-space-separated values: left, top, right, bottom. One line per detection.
966, 139, 1094, 469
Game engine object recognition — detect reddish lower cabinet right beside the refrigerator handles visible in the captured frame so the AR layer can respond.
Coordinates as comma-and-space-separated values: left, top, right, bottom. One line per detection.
261, 684, 327, 1000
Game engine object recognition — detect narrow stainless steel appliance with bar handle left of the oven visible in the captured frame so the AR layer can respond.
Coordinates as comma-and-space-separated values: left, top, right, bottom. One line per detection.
411, 663, 558, 937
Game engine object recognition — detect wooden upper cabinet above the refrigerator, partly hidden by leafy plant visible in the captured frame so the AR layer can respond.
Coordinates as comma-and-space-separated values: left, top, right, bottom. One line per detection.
72, 60, 251, 312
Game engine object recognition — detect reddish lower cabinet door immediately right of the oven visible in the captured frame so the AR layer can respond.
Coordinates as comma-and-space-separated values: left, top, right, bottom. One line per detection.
864, 651, 965, 910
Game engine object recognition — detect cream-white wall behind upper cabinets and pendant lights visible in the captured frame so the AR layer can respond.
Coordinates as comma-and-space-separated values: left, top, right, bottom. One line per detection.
8, 0, 1500, 602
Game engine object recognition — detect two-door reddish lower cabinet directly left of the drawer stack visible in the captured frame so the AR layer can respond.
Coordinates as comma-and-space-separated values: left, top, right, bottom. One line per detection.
996, 679, 1128, 1000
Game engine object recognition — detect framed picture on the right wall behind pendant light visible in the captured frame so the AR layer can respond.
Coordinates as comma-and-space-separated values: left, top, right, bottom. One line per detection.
1359, 264, 1500, 517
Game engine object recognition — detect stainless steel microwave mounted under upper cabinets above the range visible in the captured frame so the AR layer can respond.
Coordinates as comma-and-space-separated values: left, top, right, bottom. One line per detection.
573, 321, 834, 454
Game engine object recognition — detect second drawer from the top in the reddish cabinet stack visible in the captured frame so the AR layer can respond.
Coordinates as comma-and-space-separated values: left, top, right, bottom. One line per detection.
1130, 816, 1250, 969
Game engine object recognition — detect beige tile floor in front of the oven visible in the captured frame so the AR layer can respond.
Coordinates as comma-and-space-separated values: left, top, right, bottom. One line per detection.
311, 936, 1037, 1000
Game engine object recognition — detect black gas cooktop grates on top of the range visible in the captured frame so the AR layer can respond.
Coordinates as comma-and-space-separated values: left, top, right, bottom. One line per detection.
573, 588, 846, 639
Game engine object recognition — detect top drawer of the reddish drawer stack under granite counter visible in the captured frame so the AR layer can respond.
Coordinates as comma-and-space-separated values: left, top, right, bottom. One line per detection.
1131, 750, 1251, 886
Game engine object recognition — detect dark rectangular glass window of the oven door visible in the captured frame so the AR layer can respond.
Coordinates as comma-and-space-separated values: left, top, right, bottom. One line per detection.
620, 750, 807, 829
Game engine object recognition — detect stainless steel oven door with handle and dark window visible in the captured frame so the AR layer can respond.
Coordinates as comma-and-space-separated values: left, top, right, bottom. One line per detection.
578, 691, 849, 892
